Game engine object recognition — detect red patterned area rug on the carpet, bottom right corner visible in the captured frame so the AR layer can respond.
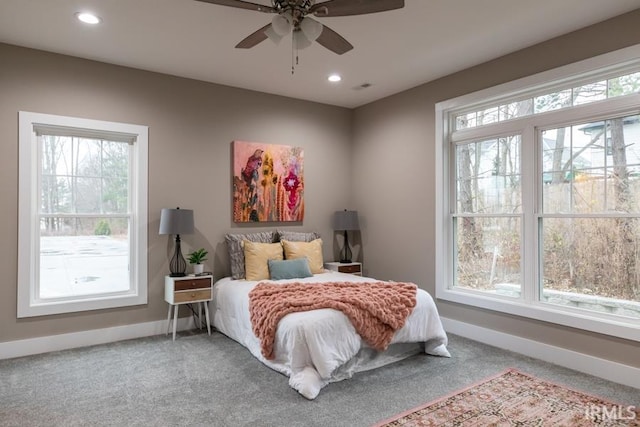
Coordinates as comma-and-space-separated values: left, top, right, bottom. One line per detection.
375, 369, 640, 427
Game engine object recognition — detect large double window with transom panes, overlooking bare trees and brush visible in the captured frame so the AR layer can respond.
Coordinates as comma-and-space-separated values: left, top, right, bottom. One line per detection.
436, 46, 640, 341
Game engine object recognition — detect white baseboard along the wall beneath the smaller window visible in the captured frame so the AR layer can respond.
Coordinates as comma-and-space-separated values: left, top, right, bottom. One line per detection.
0, 317, 195, 359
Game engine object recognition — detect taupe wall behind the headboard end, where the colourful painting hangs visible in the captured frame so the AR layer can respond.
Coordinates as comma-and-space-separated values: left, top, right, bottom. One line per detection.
0, 44, 353, 342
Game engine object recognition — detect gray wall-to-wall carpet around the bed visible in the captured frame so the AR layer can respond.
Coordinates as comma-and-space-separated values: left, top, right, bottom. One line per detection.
0, 332, 640, 427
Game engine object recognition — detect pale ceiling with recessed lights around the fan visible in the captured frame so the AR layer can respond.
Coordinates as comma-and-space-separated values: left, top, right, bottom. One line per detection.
0, 0, 640, 108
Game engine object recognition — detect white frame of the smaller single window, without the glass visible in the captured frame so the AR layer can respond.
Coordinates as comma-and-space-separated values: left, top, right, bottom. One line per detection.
17, 111, 148, 318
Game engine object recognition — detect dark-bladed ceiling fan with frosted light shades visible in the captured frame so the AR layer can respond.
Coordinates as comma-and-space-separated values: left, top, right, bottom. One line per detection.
196, 0, 404, 55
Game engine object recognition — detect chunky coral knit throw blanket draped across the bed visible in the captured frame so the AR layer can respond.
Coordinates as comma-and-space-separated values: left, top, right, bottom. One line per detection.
249, 282, 417, 359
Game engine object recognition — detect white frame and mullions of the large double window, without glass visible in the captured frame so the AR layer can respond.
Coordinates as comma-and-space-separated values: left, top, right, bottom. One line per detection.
435, 45, 640, 341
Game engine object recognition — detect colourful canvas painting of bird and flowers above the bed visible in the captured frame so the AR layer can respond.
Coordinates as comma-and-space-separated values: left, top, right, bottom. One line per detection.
233, 141, 304, 222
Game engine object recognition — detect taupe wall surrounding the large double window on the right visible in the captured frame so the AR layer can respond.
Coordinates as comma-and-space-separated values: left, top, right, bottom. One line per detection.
353, 10, 640, 367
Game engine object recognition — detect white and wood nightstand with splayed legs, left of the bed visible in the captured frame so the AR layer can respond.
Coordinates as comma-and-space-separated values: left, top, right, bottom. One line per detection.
164, 276, 213, 341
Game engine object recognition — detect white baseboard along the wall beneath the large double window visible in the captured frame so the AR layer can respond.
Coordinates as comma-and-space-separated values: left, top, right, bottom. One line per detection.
442, 318, 640, 389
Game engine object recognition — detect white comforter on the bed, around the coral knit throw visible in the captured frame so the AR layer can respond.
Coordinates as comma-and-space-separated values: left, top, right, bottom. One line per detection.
210, 272, 450, 399
